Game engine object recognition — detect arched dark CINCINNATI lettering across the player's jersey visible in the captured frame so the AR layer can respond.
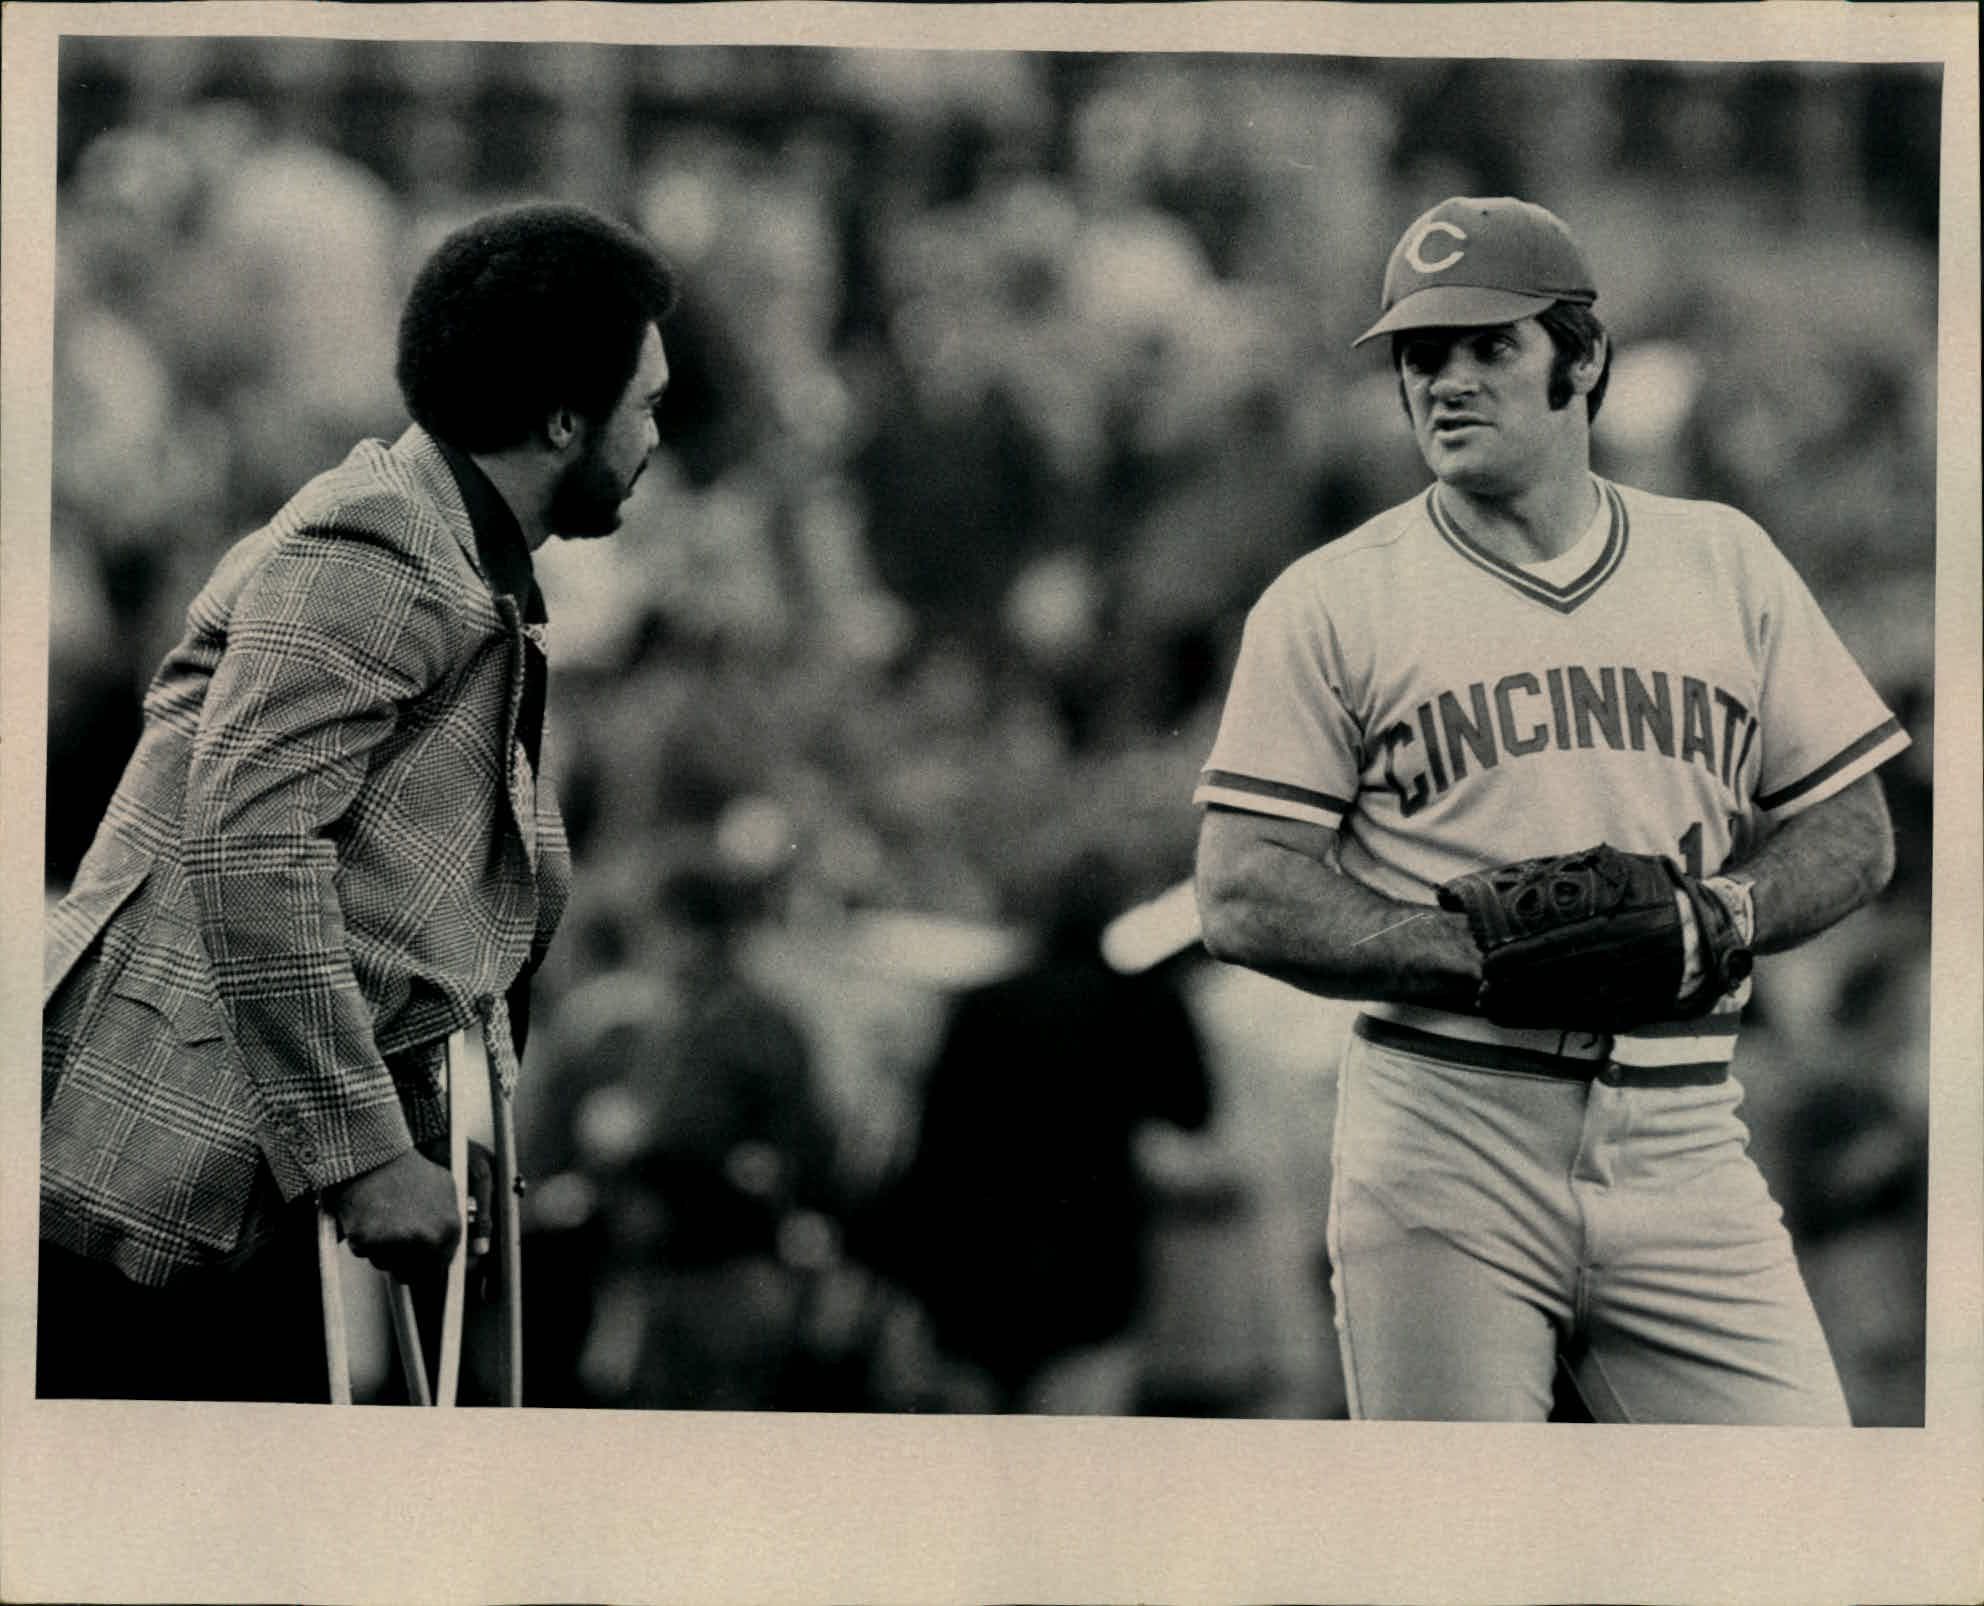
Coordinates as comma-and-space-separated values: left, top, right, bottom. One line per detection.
1379, 663, 1758, 816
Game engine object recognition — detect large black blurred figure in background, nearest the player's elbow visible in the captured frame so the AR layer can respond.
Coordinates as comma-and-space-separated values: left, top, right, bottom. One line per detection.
871, 856, 1212, 1415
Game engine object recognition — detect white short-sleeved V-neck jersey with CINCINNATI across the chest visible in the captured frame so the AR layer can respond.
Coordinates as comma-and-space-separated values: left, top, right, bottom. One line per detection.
1194, 476, 1909, 1062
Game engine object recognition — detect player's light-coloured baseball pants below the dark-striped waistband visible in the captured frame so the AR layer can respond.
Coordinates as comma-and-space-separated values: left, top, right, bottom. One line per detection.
1329, 1008, 1849, 1427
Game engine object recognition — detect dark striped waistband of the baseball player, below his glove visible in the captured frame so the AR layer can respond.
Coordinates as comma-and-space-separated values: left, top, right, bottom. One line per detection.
1355, 1004, 1740, 1088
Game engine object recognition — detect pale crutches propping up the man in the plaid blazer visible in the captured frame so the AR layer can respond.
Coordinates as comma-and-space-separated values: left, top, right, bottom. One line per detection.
317, 1032, 524, 1405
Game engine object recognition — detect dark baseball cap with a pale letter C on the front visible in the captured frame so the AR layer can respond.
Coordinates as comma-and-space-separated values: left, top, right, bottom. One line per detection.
1351, 195, 1599, 345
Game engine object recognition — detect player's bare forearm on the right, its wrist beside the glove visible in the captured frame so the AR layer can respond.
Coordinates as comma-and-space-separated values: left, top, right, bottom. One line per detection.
1730, 774, 1895, 953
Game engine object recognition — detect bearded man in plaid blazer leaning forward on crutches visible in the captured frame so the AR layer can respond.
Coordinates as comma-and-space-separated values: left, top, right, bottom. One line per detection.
38, 204, 675, 1400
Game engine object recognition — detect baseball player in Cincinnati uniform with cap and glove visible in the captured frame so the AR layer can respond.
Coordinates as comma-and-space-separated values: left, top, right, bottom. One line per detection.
1196, 197, 1909, 1425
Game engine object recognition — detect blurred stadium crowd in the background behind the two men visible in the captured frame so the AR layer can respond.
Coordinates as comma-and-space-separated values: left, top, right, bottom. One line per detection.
48, 38, 1938, 1421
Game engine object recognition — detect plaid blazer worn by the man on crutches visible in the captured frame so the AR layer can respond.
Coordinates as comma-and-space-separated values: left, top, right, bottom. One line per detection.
42, 429, 569, 1284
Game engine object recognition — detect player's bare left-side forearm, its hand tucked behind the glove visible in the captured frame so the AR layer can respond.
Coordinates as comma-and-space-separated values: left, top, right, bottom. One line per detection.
1198, 813, 1480, 1008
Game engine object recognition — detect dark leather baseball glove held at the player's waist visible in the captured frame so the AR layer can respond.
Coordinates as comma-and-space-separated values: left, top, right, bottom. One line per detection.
1440, 844, 1752, 1030
